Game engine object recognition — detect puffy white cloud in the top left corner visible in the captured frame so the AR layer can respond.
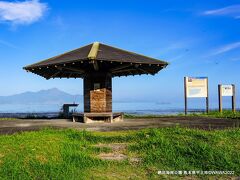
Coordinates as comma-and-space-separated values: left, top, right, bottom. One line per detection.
0, 0, 47, 24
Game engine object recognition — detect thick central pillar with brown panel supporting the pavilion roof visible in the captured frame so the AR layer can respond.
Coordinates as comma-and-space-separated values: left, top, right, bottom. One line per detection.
83, 72, 112, 112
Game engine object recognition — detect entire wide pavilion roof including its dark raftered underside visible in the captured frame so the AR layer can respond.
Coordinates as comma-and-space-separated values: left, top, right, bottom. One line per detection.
24, 42, 168, 79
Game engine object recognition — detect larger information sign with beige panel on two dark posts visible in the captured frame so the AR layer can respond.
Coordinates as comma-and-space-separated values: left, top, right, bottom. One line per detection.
184, 77, 209, 114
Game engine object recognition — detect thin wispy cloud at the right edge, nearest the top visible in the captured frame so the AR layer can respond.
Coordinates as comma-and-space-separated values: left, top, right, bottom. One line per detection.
203, 4, 240, 19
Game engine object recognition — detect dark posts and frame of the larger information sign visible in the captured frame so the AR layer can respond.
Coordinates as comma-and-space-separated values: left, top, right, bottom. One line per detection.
184, 77, 209, 115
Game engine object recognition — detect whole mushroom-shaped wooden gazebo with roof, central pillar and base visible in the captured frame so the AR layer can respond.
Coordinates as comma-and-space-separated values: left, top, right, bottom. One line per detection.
24, 42, 168, 122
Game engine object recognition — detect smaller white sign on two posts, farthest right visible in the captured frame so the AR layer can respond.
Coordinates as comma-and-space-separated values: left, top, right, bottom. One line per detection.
218, 84, 236, 112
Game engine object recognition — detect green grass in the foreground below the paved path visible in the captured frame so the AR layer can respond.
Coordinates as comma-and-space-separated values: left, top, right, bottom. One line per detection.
0, 127, 240, 179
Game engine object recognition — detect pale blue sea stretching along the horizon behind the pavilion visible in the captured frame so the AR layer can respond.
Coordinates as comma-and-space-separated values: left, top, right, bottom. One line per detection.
0, 102, 229, 118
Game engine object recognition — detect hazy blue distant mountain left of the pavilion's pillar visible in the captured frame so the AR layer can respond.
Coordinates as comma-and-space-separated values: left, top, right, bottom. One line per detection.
0, 88, 83, 104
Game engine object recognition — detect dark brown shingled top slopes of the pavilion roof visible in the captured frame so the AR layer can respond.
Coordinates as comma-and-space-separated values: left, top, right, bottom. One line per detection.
25, 42, 168, 69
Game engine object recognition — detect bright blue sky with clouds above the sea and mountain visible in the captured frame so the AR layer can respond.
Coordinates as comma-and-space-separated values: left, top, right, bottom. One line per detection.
0, 0, 240, 106
